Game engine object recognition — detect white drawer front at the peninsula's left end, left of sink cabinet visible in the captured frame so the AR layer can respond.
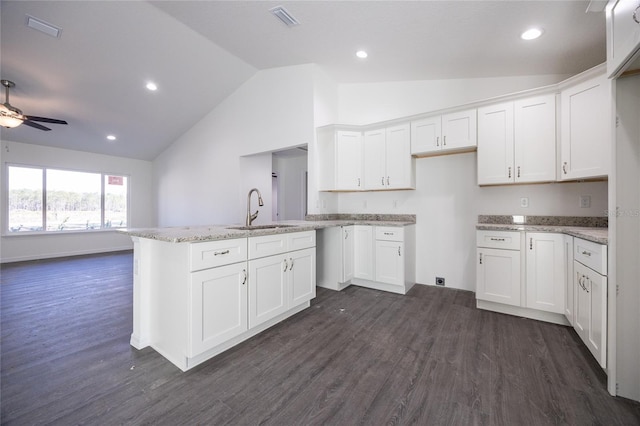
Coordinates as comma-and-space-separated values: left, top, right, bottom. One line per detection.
190, 238, 247, 271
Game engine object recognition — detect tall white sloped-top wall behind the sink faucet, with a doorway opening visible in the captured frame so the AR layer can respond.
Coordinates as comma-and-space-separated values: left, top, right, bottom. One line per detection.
154, 65, 315, 226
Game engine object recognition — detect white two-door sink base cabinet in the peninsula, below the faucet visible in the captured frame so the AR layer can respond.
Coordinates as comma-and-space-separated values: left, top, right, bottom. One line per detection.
248, 231, 316, 327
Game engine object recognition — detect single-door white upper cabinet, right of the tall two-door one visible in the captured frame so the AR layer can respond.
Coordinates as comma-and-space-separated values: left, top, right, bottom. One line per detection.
560, 75, 612, 180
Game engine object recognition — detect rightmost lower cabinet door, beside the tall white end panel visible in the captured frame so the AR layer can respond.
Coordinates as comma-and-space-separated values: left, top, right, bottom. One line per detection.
585, 271, 607, 368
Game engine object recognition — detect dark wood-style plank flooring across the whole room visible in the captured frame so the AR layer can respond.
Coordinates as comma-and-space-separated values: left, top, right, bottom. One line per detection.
0, 253, 640, 425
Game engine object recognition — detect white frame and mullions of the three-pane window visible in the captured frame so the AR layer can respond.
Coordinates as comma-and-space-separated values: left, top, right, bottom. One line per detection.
2, 162, 131, 237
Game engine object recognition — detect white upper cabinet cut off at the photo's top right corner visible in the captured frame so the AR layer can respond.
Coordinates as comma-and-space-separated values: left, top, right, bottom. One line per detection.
607, 0, 640, 77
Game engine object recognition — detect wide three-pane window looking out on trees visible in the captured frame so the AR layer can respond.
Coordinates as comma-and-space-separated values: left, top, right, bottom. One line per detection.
7, 166, 129, 233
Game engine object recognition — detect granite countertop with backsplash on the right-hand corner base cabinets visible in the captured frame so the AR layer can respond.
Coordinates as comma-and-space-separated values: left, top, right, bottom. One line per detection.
476, 216, 609, 244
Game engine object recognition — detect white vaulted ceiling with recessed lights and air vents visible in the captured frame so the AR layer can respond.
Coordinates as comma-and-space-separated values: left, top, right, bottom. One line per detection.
0, 0, 605, 160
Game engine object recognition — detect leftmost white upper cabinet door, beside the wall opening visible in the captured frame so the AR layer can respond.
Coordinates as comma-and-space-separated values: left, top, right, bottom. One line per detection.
336, 130, 362, 190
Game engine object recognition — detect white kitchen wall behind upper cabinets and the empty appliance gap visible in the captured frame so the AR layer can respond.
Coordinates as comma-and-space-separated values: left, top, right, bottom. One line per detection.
332, 76, 607, 290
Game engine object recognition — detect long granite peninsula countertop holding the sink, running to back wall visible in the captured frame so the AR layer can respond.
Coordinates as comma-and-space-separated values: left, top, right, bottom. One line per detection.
119, 215, 416, 243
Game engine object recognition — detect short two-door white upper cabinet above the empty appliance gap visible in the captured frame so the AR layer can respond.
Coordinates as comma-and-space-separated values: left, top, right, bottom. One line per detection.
411, 109, 477, 157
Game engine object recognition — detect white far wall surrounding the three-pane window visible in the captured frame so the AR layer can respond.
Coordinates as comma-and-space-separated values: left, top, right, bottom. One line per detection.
0, 141, 155, 262
